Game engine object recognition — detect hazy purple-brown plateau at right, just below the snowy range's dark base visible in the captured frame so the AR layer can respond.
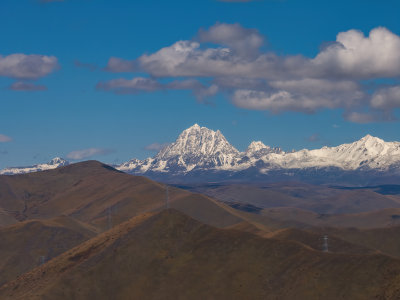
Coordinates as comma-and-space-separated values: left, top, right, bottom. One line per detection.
189, 183, 400, 214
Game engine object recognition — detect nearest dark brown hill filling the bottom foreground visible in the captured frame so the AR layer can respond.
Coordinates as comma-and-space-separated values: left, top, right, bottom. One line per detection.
0, 210, 400, 300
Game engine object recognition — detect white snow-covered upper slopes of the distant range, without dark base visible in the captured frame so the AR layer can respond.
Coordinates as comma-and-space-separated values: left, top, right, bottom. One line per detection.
0, 124, 400, 175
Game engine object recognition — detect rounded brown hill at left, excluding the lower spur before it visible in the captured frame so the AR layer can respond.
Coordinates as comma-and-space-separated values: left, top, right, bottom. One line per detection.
0, 161, 241, 230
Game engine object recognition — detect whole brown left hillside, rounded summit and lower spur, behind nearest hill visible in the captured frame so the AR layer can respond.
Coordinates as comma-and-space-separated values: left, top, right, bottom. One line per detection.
0, 161, 243, 284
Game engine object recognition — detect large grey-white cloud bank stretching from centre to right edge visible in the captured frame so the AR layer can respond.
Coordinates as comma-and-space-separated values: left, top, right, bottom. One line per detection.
98, 23, 400, 122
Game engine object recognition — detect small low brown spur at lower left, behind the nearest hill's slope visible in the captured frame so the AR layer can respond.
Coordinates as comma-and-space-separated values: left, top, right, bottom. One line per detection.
0, 216, 96, 285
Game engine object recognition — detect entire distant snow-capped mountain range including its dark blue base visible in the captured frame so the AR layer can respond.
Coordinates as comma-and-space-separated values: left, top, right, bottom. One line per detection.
0, 124, 400, 185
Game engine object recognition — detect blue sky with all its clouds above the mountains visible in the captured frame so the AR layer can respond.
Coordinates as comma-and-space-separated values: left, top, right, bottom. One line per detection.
0, 0, 400, 168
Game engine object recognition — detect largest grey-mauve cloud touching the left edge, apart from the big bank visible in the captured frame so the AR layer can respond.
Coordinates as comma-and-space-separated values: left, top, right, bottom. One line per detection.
0, 53, 59, 79
